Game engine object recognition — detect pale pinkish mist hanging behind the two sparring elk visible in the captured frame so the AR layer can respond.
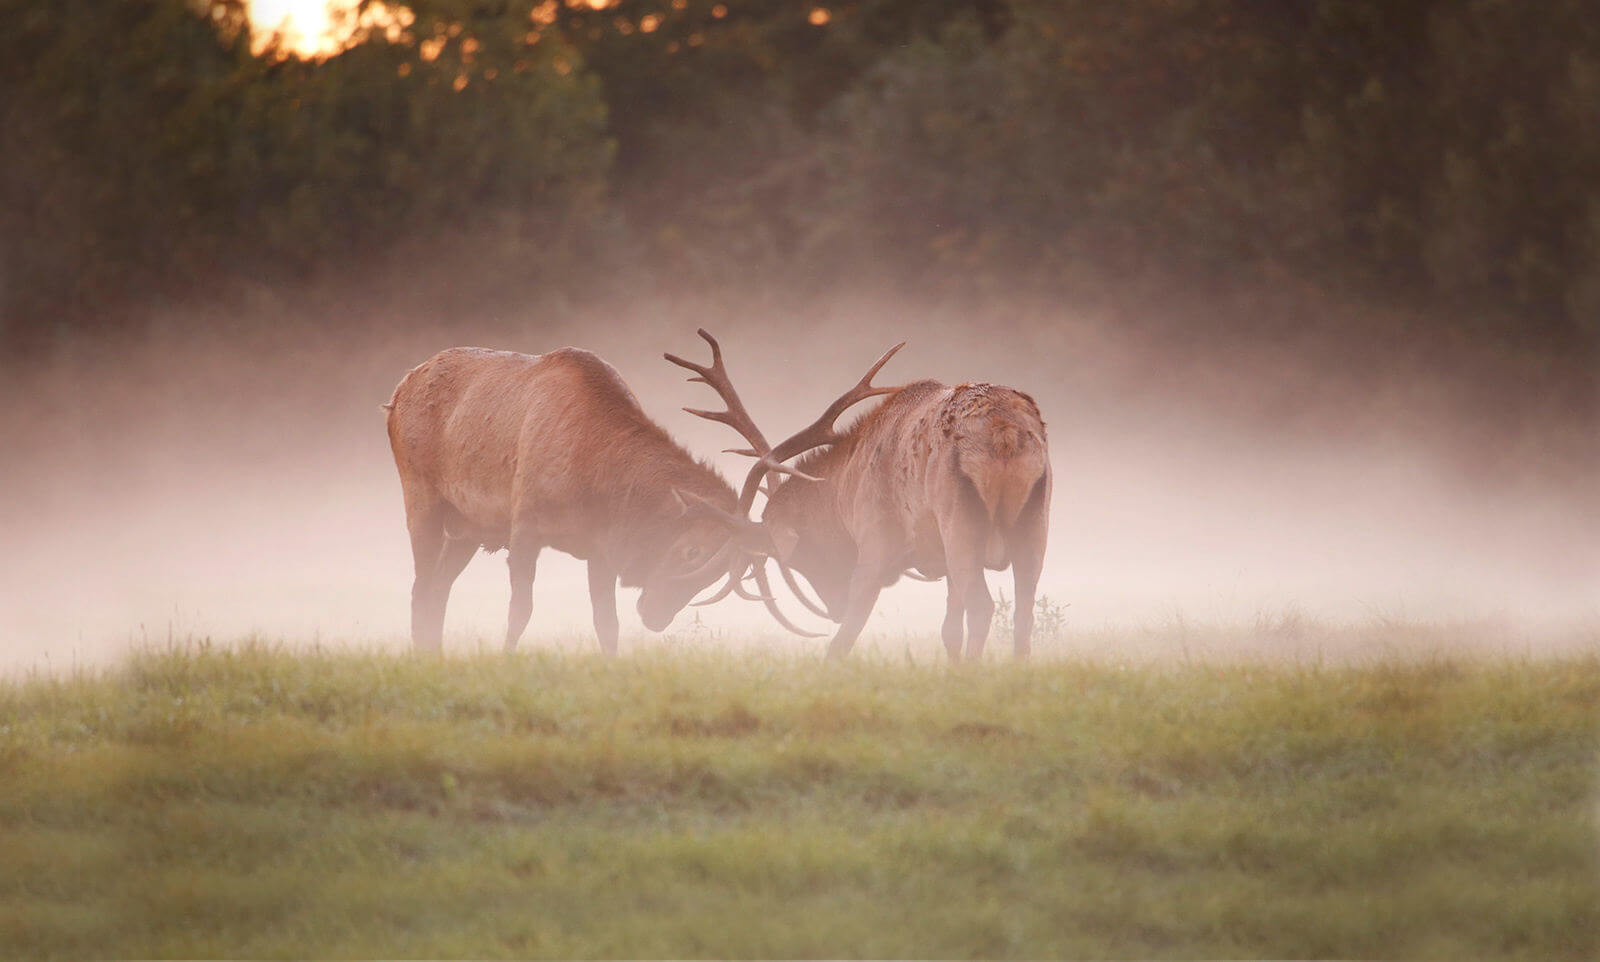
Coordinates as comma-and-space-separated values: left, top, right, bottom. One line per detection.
0, 283, 1600, 671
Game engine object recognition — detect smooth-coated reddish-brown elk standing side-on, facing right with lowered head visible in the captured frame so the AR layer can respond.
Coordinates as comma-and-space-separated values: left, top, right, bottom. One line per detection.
384, 347, 750, 653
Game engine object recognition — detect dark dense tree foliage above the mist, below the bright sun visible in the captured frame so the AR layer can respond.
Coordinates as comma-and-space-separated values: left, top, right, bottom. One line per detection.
0, 0, 1600, 371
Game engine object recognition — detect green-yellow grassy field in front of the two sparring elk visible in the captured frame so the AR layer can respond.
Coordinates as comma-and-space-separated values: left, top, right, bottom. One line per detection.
0, 633, 1600, 959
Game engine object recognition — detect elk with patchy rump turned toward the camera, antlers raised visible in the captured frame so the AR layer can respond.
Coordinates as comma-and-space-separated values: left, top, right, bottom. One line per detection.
667, 331, 1051, 661
